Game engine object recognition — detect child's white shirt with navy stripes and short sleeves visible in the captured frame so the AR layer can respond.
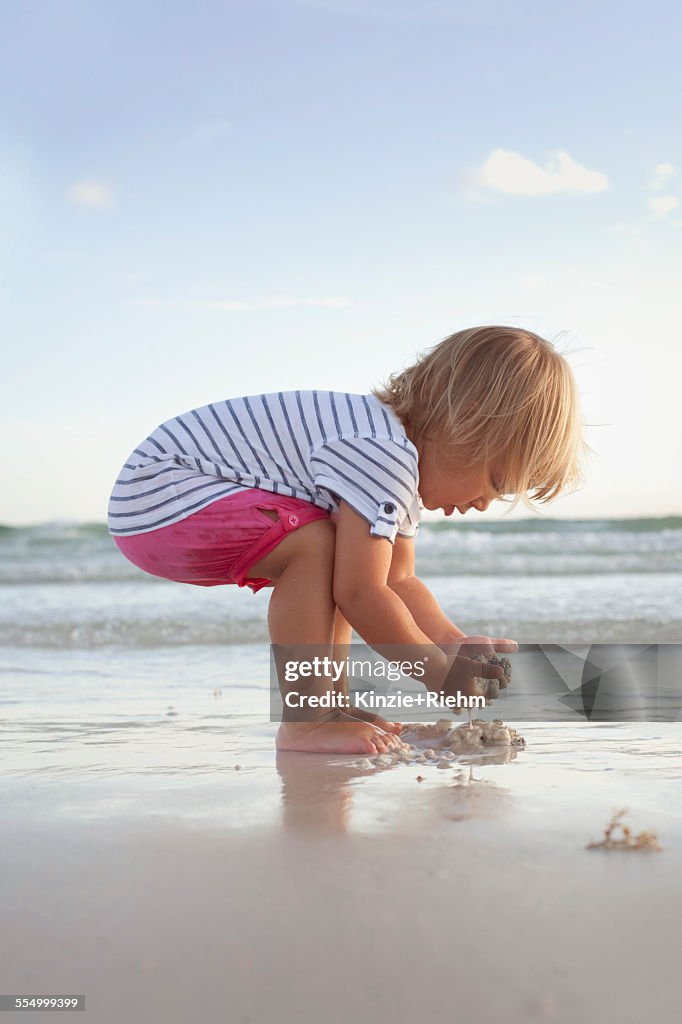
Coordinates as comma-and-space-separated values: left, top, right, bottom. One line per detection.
109, 391, 419, 543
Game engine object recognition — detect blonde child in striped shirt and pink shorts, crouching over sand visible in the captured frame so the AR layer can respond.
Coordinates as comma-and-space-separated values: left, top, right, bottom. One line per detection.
109, 327, 582, 754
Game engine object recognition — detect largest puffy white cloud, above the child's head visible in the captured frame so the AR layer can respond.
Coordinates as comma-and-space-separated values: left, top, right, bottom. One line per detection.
468, 150, 608, 196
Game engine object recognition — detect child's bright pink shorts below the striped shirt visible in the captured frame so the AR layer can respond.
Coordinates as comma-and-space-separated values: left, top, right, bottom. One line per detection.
114, 488, 330, 593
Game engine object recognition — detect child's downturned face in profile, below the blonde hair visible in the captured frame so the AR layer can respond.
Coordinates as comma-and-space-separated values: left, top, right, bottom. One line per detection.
411, 439, 504, 515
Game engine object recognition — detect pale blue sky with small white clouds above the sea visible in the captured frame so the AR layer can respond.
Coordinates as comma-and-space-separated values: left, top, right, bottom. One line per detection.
0, 0, 682, 524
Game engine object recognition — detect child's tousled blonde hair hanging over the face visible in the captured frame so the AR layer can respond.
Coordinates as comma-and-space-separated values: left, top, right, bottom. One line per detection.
373, 327, 587, 506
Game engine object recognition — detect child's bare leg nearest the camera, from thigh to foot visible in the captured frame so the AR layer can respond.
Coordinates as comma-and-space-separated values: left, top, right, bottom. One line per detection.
248, 519, 399, 755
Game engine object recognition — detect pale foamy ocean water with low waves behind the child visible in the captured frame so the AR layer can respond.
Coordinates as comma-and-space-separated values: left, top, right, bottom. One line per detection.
0, 517, 682, 774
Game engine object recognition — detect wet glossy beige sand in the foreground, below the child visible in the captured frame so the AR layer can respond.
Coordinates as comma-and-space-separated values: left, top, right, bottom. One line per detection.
0, 716, 682, 1024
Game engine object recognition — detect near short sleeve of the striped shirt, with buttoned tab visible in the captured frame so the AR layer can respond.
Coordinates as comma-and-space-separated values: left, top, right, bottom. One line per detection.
310, 437, 419, 543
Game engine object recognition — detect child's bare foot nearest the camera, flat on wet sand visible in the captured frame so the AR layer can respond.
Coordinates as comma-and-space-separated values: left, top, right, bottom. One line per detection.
275, 719, 404, 757
